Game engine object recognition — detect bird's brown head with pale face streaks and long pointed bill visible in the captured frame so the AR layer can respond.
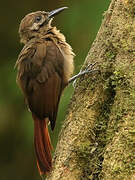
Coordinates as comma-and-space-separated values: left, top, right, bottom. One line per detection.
19, 7, 67, 44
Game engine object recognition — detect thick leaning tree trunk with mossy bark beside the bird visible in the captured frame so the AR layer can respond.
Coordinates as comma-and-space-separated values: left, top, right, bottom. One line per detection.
47, 0, 135, 180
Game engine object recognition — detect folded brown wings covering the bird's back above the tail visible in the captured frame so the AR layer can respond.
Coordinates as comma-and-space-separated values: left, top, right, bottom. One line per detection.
17, 41, 64, 129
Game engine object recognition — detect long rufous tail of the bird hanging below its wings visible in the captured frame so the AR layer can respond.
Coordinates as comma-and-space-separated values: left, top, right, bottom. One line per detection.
32, 114, 52, 175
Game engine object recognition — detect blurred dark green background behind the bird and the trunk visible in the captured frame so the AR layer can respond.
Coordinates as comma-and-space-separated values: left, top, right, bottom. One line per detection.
0, 0, 110, 180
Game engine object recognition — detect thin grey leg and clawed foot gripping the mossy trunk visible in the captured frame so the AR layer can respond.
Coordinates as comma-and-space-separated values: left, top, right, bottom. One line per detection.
68, 62, 97, 85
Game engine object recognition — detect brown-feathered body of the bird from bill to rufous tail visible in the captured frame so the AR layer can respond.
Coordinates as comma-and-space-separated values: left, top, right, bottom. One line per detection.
16, 8, 74, 175
